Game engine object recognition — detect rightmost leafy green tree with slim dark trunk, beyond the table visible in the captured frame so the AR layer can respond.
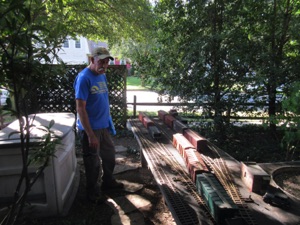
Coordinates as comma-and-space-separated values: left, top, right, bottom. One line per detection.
244, 0, 300, 133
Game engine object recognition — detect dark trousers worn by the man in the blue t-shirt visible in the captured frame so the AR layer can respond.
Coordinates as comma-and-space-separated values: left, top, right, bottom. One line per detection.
78, 129, 116, 193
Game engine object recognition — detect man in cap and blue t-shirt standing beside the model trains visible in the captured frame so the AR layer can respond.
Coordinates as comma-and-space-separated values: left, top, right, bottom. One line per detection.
74, 47, 123, 203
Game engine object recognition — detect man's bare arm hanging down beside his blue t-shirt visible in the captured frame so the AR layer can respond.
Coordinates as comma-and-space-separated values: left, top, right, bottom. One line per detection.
76, 99, 99, 149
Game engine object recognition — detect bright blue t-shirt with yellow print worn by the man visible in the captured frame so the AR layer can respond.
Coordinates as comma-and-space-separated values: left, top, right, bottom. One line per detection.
74, 68, 109, 130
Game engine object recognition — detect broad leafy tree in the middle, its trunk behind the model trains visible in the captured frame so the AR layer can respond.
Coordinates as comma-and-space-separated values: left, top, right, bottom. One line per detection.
130, 0, 254, 137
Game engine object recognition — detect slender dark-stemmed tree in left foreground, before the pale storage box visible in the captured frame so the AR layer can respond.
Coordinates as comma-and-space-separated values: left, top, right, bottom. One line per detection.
0, 1, 71, 224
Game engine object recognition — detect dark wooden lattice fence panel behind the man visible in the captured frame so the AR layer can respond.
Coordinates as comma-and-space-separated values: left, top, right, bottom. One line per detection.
30, 65, 127, 129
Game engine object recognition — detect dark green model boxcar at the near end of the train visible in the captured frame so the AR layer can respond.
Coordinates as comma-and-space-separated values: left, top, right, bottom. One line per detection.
196, 174, 238, 224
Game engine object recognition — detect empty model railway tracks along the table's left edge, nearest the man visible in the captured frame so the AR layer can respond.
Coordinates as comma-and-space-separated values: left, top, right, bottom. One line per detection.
130, 120, 215, 225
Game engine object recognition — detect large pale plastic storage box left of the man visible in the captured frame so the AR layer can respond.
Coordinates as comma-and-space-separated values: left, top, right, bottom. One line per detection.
0, 113, 79, 216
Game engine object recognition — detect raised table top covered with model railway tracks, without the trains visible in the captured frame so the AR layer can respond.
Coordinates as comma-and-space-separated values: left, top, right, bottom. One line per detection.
128, 111, 300, 225
